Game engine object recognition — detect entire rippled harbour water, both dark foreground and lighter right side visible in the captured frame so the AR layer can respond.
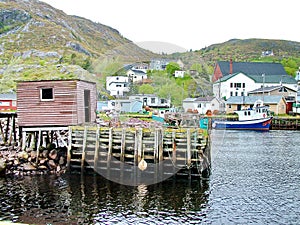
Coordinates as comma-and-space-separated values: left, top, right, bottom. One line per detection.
0, 130, 300, 224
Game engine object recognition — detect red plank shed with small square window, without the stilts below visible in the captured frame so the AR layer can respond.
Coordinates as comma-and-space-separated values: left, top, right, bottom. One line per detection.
17, 79, 97, 127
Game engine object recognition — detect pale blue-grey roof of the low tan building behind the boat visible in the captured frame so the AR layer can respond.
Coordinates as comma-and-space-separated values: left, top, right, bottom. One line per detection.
226, 95, 283, 105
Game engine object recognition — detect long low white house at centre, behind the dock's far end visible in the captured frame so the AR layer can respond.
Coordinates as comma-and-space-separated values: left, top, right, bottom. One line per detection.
129, 94, 171, 108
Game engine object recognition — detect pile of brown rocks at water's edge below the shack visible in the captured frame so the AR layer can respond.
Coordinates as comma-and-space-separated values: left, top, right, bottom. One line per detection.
0, 144, 67, 176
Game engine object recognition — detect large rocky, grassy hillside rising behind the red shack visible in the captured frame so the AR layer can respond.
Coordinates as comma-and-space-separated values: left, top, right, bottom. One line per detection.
0, 0, 155, 91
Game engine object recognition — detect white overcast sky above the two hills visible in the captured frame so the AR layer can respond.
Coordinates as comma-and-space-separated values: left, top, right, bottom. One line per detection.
42, 0, 300, 53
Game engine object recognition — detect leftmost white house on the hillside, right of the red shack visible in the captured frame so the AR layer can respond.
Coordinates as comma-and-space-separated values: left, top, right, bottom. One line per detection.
106, 76, 130, 96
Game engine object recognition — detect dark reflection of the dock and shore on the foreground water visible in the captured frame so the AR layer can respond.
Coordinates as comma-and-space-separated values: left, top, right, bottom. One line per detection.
0, 175, 208, 224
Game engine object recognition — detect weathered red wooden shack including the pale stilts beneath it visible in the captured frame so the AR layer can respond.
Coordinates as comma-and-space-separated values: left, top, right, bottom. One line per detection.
17, 79, 97, 150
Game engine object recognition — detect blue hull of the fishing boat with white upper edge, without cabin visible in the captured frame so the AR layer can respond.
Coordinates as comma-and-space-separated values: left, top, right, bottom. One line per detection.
212, 117, 272, 130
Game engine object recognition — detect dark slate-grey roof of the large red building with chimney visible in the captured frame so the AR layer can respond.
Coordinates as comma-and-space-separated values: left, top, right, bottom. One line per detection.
217, 61, 287, 76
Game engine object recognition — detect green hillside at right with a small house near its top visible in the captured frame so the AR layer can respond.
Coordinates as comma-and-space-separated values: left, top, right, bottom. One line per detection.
175, 39, 300, 76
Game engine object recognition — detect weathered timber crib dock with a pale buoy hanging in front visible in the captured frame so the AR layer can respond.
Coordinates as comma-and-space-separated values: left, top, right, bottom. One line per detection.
67, 126, 210, 181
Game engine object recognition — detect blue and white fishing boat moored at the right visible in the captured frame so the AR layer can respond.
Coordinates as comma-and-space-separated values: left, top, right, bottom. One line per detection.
212, 100, 272, 130
